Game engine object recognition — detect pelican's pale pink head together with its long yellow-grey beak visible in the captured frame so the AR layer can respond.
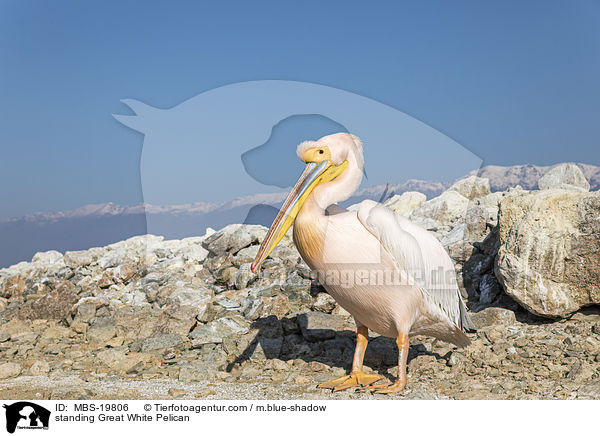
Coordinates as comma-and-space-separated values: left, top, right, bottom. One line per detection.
250, 133, 363, 272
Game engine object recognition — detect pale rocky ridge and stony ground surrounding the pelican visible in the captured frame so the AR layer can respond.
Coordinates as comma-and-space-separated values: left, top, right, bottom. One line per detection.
0, 163, 600, 399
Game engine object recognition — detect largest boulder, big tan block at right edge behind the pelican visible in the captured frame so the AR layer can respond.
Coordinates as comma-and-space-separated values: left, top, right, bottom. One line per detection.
495, 189, 600, 317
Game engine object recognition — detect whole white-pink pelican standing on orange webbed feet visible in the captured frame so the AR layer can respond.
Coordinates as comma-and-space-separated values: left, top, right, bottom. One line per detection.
251, 133, 472, 393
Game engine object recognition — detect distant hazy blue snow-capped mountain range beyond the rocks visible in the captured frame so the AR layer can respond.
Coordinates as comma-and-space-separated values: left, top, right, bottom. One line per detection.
0, 164, 600, 268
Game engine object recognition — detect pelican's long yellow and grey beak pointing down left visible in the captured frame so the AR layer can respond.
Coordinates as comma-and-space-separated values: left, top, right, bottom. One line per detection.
250, 160, 348, 273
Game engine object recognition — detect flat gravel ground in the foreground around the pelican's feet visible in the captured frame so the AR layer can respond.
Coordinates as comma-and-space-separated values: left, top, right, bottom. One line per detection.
0, 308, 600, 400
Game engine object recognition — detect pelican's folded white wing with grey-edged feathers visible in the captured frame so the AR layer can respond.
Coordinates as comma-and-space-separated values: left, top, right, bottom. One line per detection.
358, 200, 473, 331
